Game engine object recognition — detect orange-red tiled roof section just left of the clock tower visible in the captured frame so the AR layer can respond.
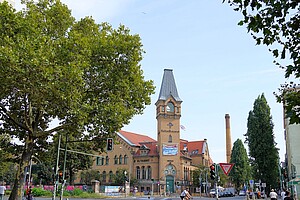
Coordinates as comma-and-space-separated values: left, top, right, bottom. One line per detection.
119, 130, 156, 146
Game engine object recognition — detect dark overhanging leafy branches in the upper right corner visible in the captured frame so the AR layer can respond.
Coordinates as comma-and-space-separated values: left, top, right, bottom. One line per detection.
223, 0, 300, 123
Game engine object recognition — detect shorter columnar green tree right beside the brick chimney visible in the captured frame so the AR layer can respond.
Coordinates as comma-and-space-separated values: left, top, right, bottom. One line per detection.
229, 139, 251, 190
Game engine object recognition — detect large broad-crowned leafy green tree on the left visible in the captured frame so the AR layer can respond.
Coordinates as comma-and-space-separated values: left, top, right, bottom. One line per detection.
0, 0, 154, 200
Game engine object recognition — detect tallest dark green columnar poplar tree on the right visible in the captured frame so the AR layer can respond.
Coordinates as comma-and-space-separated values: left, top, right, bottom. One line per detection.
245, 94, 279, 192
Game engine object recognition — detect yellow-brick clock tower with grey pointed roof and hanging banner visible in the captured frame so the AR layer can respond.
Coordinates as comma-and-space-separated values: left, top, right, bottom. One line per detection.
155, 69, 182, 193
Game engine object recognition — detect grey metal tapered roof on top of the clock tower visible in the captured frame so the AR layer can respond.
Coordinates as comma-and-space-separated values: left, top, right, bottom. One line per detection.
158, 69, 182, 101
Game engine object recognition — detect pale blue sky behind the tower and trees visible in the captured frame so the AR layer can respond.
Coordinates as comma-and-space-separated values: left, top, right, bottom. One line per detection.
15, 0, 286, 163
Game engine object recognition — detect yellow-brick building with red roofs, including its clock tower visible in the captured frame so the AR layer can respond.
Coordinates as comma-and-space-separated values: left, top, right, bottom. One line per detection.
93, 69, 211, 194
